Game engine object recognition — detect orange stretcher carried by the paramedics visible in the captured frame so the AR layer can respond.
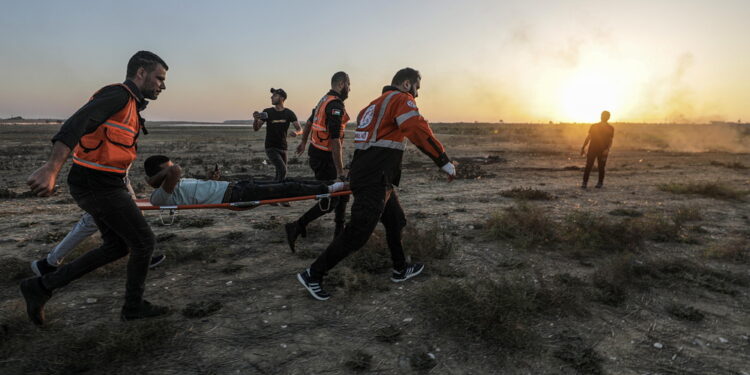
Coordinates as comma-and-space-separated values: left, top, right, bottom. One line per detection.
135, 190, 352, 225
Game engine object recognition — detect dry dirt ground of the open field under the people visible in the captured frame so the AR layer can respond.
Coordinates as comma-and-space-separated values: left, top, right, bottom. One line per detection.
0, 124, 750, 375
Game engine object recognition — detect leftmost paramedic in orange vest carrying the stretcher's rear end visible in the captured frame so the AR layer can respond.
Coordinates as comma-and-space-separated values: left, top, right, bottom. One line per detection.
21, 51, 169, 325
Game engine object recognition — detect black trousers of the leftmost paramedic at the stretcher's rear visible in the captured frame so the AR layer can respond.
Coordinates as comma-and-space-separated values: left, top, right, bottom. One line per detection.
42, 185, 156, 306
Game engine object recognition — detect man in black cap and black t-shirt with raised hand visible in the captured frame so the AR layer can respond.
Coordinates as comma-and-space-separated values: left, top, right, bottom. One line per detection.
253, 88, 302, 181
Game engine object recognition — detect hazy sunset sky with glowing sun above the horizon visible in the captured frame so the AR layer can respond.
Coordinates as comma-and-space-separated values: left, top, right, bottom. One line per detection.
0, 0, 750, 122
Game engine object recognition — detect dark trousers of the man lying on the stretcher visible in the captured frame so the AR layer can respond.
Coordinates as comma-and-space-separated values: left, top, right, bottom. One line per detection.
224, 179, 328, 203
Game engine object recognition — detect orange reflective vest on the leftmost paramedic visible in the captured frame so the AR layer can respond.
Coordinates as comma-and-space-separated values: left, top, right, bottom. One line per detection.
73, 84, 141, 174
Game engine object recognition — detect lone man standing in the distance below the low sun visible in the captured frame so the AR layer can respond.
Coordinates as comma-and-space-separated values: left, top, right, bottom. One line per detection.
581, 111, 615, 189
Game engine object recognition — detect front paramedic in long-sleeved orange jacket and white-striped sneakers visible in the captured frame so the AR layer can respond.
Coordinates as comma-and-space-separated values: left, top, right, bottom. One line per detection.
297, 68, 456, 301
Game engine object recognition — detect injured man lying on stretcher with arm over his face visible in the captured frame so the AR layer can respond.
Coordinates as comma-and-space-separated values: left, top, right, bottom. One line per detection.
143, 155, 348, 206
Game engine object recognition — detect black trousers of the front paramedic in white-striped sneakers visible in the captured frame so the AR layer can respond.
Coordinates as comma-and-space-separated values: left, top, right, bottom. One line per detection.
310, 184, 406, 280
